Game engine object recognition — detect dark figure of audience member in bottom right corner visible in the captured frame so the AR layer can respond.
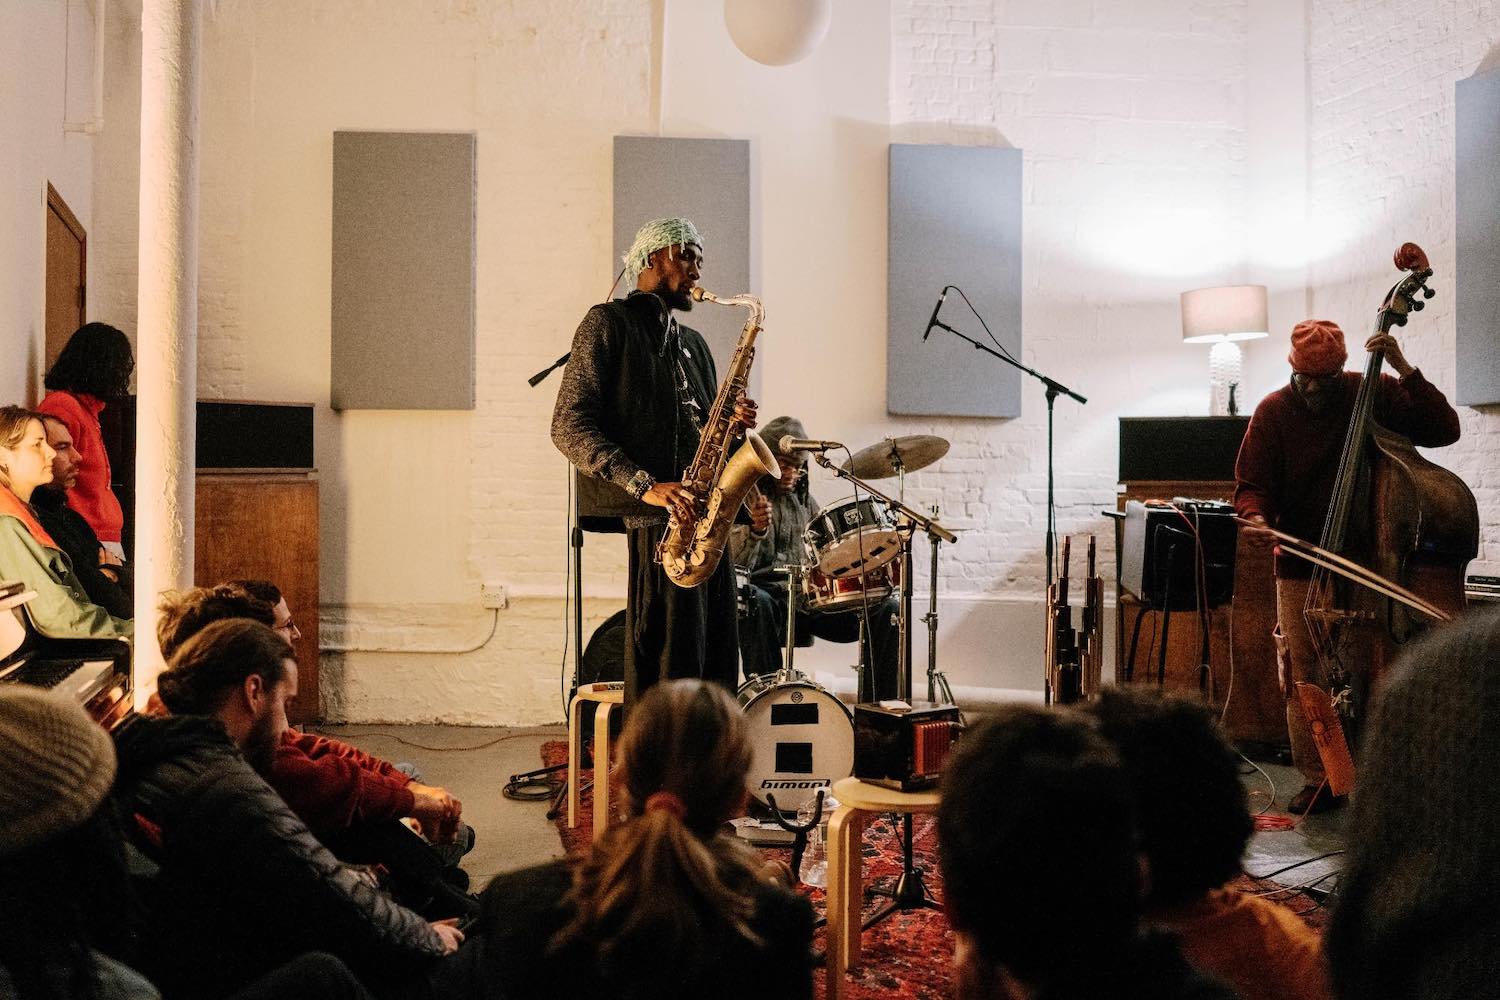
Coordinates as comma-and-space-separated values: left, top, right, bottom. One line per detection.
1328, 610, 1500, 1000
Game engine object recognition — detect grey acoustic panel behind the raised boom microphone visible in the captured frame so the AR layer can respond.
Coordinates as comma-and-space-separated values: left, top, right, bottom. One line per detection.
885, 144, 1022, 417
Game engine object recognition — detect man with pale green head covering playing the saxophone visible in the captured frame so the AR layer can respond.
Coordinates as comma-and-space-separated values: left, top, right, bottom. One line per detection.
552, 219, 768, 709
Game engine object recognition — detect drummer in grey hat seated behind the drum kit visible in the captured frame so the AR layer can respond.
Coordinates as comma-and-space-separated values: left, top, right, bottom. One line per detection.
729, 417, 900, 700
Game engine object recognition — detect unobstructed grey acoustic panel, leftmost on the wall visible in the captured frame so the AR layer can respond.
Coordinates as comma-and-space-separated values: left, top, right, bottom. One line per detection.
330, 132, 474, 409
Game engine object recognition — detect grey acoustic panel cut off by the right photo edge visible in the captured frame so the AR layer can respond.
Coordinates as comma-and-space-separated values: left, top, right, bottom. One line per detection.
1455, 72, 1500, 406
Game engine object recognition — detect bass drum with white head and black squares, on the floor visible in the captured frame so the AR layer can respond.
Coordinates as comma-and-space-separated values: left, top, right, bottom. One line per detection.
740, 675, 854, 813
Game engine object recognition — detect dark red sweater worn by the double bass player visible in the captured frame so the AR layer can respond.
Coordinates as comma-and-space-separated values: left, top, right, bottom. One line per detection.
1235, 370, 1460, 577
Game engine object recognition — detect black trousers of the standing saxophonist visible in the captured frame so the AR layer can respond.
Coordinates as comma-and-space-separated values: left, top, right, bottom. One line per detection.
626, 525, 740, 711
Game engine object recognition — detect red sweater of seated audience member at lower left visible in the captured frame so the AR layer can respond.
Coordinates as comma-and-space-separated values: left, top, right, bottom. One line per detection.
270, 730, 416, 841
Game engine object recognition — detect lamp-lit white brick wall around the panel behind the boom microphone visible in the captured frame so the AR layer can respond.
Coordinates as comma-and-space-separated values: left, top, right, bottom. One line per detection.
891, 0, 1247, 622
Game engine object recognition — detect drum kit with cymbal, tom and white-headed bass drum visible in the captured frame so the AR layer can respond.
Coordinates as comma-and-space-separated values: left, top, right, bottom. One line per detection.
737, 435, 957, 813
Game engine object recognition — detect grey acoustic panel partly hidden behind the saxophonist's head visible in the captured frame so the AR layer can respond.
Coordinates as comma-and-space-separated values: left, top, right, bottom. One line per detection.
614, 135, 750, 396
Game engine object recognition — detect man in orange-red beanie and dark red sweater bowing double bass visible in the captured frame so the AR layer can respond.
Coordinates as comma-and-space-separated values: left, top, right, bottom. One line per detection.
1235, 319, 1460, 813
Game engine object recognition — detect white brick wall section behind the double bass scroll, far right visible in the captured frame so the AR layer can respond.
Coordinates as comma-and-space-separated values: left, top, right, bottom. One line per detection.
1310, 0, 1500, 574
